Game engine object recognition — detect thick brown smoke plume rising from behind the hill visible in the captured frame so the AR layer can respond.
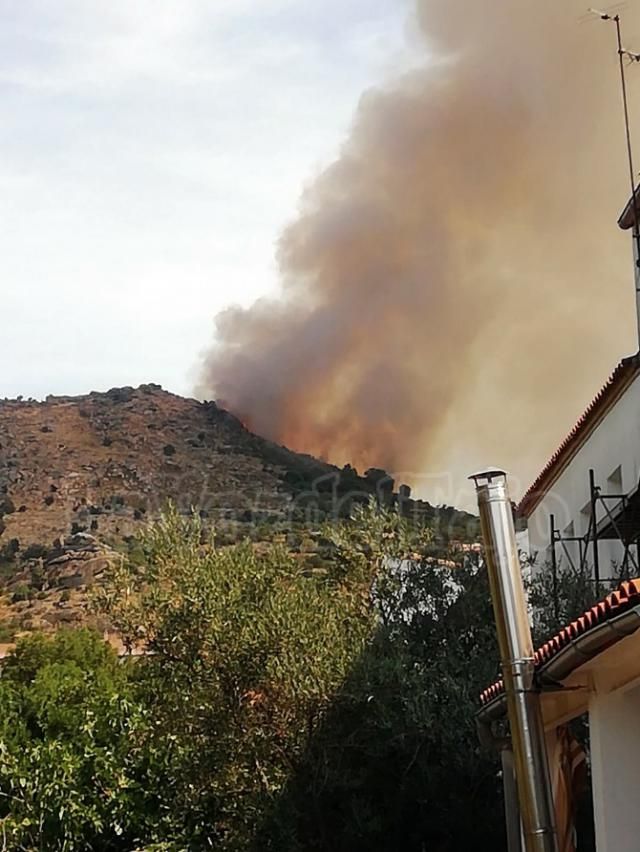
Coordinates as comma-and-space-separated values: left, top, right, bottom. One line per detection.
201, 0, 640, 499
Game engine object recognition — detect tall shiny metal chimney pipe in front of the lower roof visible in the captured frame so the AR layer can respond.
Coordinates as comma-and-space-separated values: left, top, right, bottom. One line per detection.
470, 469, 558, 852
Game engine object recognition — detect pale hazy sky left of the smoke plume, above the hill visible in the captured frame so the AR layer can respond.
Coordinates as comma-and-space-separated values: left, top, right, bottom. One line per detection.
0, 0, 416, 397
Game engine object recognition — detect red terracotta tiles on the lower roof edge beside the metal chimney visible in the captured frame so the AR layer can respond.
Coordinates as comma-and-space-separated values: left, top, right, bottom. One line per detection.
480, 578, 640, 706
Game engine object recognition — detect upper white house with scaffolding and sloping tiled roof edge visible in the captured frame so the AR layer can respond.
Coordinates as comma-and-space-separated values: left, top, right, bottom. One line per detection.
518, 194, 640, 588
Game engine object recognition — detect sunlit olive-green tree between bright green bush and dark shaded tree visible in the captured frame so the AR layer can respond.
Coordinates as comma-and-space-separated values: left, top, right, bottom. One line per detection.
99, 513, 375, 849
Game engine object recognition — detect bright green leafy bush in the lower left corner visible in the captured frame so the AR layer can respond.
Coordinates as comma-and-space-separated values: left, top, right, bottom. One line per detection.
0, 630, 155, 850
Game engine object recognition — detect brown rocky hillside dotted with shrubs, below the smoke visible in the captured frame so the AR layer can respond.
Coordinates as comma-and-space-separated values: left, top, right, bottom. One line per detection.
0, 384, 475, 642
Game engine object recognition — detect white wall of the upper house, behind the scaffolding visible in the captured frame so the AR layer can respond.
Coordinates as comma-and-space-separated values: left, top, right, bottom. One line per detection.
528, 376, 640, 580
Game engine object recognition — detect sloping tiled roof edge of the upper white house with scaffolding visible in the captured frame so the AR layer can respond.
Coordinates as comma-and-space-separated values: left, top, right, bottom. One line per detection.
518, 353, 640, 517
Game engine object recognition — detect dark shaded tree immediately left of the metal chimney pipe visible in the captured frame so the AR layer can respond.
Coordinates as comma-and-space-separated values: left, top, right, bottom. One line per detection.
265, 507, 502, 852
